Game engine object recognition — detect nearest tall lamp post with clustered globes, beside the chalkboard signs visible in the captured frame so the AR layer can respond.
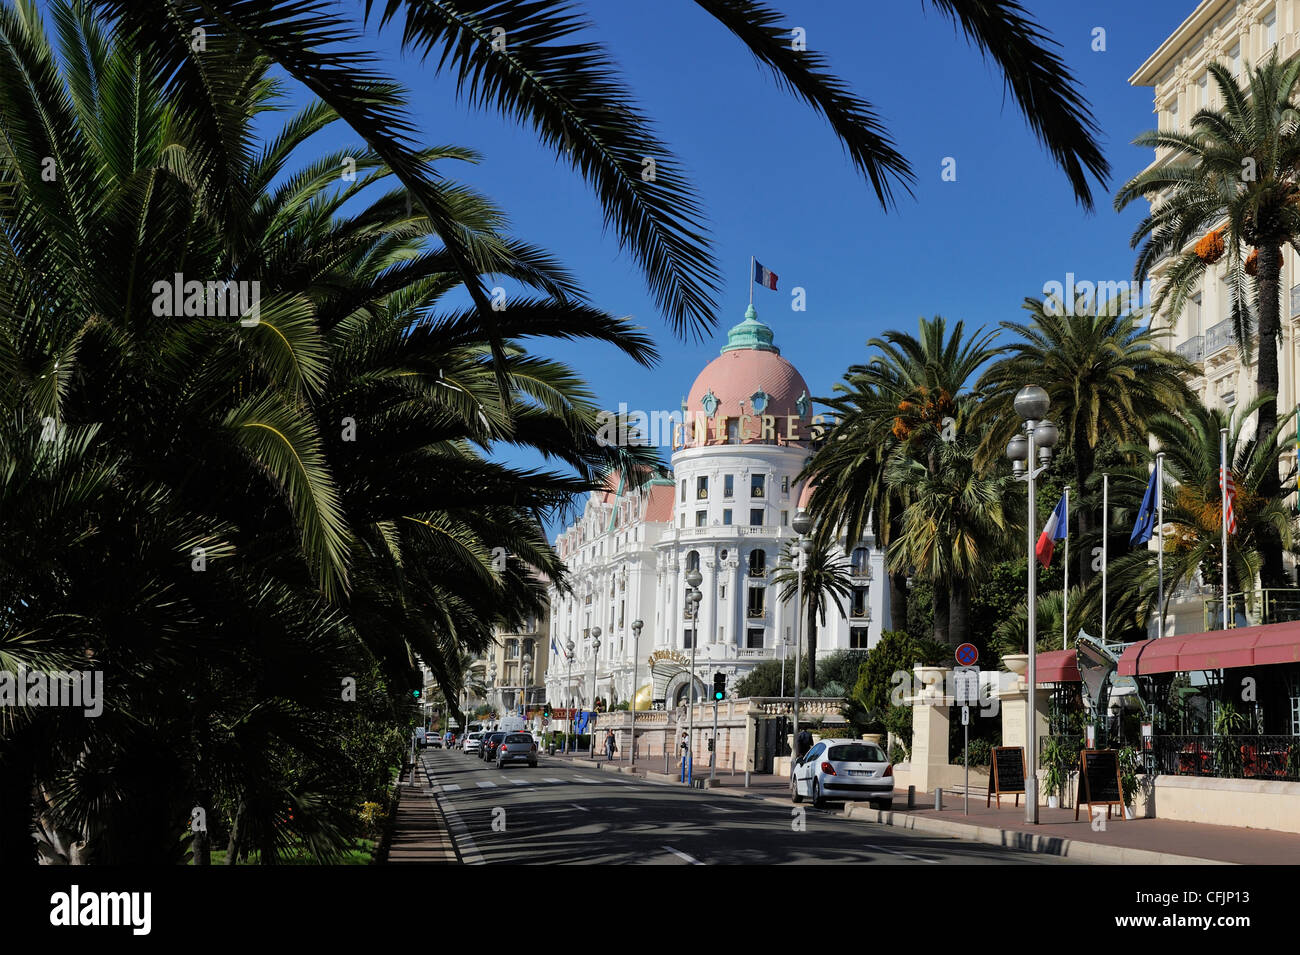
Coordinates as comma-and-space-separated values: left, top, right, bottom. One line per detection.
1006, 385, 1060, 825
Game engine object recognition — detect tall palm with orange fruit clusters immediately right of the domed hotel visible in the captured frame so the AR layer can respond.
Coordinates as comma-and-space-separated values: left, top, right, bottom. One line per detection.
801, 316, 996, 633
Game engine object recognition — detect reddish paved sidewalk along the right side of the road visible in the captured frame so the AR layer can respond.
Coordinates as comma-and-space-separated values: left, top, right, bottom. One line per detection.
555, 754, 1300, 865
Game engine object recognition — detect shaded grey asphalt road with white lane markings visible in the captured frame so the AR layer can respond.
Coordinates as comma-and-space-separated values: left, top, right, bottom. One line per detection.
420, 750, 1070, 865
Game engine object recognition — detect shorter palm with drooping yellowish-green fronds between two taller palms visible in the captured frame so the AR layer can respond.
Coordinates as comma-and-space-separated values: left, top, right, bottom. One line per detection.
885, 439, 1013, 646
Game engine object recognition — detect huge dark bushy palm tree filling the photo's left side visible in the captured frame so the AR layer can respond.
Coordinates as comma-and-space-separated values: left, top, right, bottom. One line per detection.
0, 4, 654, 863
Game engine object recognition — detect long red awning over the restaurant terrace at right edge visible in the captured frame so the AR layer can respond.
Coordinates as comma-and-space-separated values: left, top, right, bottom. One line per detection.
1118, 621, 1300, 677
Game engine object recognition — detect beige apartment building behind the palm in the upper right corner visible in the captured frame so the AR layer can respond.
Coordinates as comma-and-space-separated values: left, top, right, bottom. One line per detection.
1128, 0, 1300, 426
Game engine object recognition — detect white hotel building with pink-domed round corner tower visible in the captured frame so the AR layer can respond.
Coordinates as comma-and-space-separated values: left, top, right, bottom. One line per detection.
546, 305, 889, 709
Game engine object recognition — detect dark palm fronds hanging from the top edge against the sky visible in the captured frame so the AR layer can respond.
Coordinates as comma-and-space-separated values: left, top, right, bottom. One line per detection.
88, 0, 1109, 343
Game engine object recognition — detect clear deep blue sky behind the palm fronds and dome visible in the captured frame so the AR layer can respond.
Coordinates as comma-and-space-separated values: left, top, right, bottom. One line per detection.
244, 0, 1195, 530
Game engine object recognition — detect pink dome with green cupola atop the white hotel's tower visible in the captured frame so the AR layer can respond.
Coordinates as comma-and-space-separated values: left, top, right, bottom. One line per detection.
684, 305, 813, 447
